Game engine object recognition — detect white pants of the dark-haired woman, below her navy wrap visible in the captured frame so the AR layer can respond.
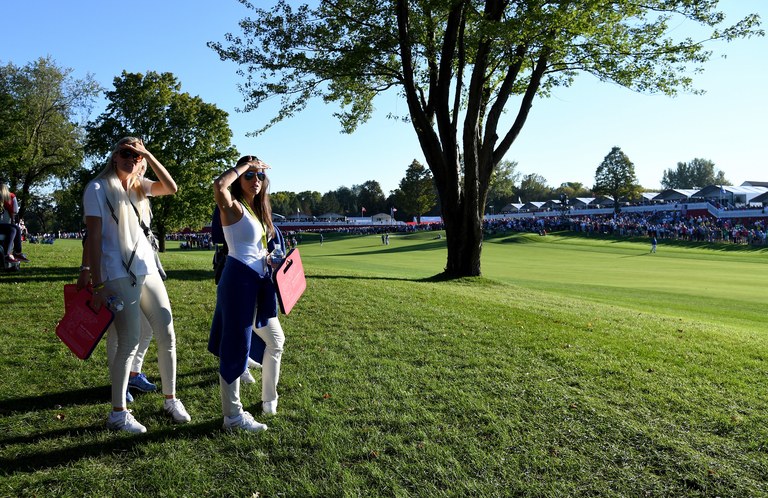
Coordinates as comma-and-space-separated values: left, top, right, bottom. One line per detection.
219, 317, 285, 417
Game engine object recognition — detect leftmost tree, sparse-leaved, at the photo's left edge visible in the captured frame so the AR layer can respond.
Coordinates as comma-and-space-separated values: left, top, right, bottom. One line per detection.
0, 57, 101, 218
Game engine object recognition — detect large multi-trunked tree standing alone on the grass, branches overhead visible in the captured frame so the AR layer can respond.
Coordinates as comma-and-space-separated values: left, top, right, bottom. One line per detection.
210, 0, 759, 276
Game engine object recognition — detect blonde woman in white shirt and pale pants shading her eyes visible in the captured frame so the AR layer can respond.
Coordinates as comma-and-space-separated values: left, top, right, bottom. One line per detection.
78, 137, 191, 433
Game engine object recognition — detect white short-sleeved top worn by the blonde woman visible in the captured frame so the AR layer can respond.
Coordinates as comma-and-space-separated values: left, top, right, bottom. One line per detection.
83, 178, 157, 282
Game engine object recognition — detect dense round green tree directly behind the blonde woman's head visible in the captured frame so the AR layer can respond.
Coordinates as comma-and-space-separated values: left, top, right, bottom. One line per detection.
86, 71, 238, 250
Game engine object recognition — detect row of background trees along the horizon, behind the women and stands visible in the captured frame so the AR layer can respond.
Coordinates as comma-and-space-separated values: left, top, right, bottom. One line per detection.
0, 57, 730, 240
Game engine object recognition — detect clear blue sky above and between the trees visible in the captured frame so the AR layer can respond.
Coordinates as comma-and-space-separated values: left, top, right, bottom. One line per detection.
0, 0, 768, 194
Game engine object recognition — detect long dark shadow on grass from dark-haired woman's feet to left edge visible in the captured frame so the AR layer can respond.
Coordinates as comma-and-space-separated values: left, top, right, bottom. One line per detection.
0, 418, 222, 476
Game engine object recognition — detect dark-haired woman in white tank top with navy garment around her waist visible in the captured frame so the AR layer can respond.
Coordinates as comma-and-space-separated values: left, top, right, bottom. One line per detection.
208, 156, 285, 432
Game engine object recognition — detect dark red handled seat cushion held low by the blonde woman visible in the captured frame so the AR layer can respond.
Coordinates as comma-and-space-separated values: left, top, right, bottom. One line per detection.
56, 284, 115, 360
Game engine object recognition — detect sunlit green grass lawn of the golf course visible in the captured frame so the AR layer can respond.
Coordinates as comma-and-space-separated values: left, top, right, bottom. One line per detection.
0, 233, 768, 497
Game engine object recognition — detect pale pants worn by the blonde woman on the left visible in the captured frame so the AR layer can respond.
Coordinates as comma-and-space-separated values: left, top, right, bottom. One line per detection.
105, 273, 176, 408
